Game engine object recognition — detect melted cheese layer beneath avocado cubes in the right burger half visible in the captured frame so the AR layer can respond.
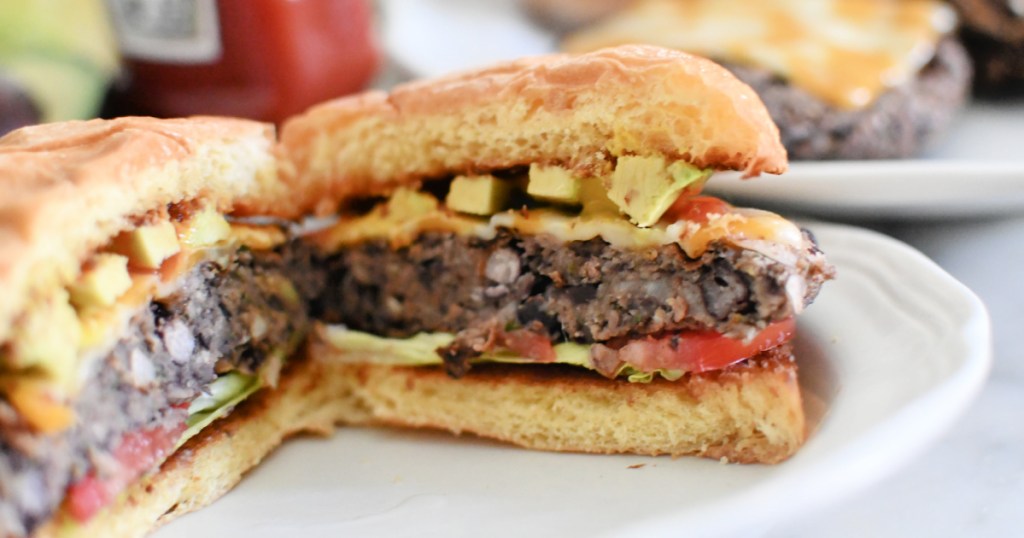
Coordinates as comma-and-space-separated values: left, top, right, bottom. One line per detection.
308, 191, 803, 257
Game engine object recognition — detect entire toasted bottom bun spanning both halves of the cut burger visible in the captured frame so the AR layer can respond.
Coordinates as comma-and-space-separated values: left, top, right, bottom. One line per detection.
38, 349, 806, 538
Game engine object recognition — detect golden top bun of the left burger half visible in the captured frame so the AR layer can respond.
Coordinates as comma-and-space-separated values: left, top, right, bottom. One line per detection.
0, 118, 273, 342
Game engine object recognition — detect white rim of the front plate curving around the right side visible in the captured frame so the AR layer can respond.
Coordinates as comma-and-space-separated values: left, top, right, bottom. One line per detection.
608, 222, 992, 537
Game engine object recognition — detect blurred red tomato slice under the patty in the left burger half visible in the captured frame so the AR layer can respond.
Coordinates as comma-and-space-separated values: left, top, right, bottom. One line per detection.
65, 422, 185, 523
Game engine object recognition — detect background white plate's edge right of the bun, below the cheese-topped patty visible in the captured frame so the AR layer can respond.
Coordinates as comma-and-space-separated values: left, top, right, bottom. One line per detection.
708, 101, 1024, 219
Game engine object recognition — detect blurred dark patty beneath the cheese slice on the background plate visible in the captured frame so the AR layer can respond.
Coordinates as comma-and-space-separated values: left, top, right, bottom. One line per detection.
724, 38, 971, 160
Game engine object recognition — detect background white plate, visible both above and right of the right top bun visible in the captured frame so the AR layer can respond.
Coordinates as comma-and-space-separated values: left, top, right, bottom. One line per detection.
381, 0, 1024, 218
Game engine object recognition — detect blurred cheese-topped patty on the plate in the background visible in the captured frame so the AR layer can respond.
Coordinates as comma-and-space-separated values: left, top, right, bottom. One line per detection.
563, 0, 971, 160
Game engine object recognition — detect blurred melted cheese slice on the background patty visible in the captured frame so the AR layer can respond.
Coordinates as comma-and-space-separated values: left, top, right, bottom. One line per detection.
564, 0, 955, 109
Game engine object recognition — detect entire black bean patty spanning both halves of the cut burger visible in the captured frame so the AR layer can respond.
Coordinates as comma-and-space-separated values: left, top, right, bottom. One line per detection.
0, 222, 831, 535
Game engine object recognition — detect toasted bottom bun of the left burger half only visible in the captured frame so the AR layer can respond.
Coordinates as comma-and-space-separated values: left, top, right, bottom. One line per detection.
36, 348, 367, 538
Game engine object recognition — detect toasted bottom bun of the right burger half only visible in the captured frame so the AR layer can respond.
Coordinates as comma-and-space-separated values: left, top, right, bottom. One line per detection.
344, 349, 806, 463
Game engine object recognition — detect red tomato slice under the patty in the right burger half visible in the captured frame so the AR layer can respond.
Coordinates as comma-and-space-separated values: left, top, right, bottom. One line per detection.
617, 318, 797, 373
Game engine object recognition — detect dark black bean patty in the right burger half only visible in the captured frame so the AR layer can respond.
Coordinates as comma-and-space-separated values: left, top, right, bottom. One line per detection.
301, 230, 830, 375
